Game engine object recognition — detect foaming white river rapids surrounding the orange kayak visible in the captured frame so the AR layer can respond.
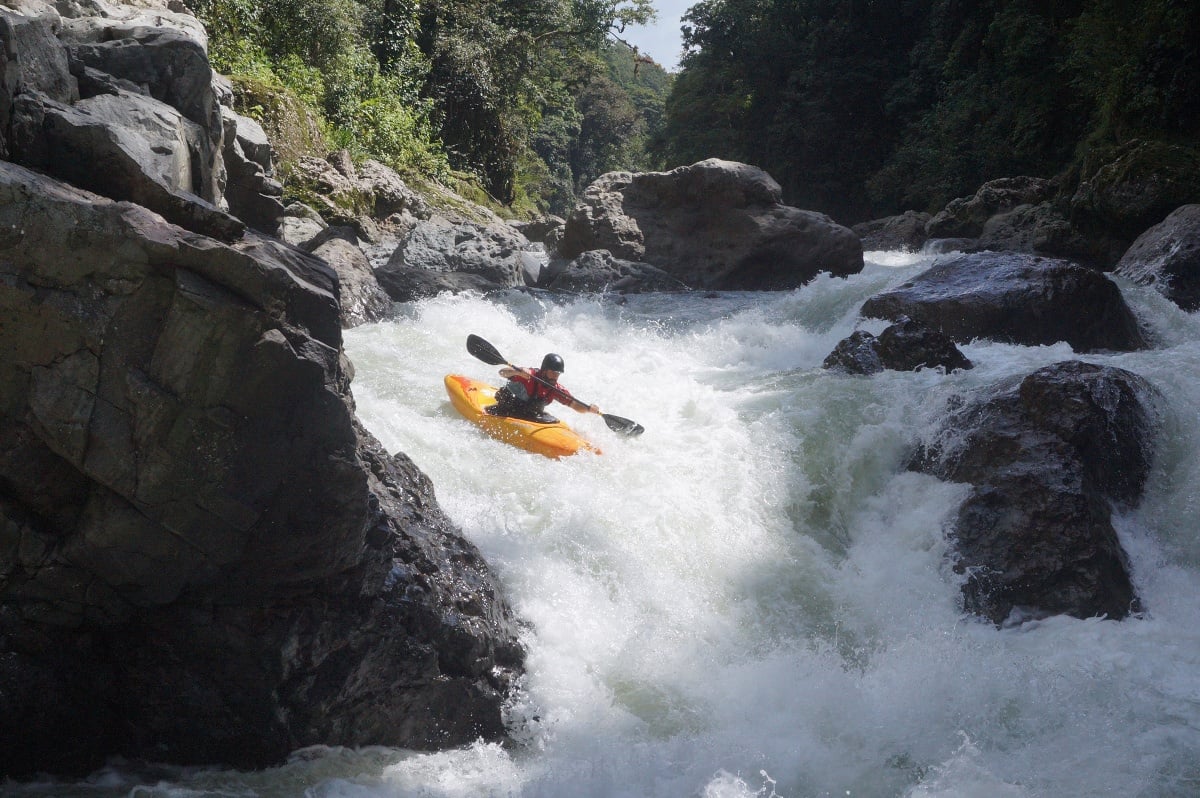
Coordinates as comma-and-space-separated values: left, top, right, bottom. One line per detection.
9, 252, 1200, 798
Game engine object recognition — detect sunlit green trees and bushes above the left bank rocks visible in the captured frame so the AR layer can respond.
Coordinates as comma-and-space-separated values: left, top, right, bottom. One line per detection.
197, 0, 668, 212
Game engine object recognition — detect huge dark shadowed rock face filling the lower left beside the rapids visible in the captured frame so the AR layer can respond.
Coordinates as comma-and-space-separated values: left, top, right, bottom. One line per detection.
0, 158, 520, 778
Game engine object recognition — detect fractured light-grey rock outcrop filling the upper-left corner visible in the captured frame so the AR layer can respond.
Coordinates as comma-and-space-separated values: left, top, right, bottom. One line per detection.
0, 0, 244, 241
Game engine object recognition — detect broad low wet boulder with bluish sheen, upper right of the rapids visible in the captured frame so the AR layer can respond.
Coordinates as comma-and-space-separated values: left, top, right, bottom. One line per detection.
862, 252, 1146, 352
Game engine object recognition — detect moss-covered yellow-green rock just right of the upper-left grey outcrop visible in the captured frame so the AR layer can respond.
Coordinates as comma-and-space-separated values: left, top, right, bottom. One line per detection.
229, 76, 331, 164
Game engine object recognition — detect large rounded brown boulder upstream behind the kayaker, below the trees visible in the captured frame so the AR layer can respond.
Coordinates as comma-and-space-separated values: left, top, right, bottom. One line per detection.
558, 158, 863, 290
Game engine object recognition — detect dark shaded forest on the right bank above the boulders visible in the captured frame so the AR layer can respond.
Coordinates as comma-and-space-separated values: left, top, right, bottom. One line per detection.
656, 0, 1200, 222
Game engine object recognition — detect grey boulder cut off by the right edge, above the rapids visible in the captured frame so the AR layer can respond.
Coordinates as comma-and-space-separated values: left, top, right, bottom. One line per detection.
1116, 205, 1200, 312
